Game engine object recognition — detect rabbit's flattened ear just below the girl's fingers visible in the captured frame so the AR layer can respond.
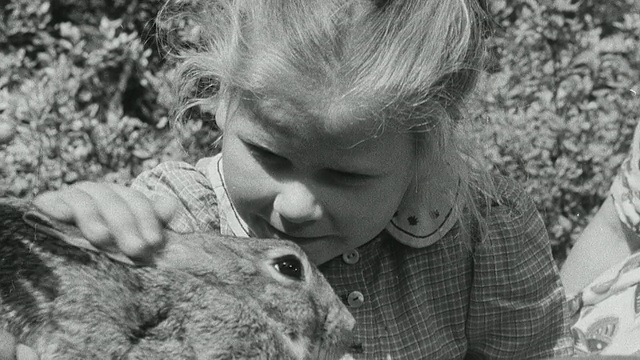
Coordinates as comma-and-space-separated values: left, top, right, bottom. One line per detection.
22, 210, 135, 265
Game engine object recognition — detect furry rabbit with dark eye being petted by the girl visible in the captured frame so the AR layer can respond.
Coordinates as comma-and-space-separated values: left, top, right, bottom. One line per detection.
0, 199, 355, 360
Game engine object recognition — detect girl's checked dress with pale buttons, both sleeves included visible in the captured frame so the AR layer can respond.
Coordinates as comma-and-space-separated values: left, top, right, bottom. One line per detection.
133, 157, 573, 360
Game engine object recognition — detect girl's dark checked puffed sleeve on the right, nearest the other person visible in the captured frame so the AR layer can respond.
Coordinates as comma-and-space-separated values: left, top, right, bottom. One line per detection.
467, 179, 573, 359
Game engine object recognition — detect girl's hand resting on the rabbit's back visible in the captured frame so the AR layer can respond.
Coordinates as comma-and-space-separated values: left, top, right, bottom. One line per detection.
33, 182, 177, 262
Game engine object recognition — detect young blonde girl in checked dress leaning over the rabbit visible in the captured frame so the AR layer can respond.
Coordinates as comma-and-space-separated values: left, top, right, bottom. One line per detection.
10, 0, 571, 359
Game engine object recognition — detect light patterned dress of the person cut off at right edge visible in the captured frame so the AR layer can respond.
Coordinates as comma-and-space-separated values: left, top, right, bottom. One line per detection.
569, 123, 640, 355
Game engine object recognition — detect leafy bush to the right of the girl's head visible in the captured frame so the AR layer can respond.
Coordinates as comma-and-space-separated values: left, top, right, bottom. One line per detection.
472, 0, 640, 262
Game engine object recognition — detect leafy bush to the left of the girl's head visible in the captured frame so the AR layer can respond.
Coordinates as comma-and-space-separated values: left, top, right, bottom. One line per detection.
0, 0, 219, 196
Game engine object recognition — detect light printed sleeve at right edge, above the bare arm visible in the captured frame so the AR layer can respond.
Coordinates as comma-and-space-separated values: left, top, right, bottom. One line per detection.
610, 122, 640, 235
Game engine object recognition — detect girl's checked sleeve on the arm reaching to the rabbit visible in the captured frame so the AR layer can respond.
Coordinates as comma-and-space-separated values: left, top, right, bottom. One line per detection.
131, 161, 220, 233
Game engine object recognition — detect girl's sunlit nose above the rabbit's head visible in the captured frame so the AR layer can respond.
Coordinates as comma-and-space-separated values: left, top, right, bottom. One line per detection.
273, 182, 322, 224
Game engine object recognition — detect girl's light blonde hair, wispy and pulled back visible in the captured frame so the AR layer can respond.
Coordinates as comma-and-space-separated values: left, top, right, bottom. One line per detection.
159, 0, 493, 242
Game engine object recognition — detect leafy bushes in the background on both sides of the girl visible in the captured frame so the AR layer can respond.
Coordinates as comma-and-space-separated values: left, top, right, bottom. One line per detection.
0, 0, 640, 263
